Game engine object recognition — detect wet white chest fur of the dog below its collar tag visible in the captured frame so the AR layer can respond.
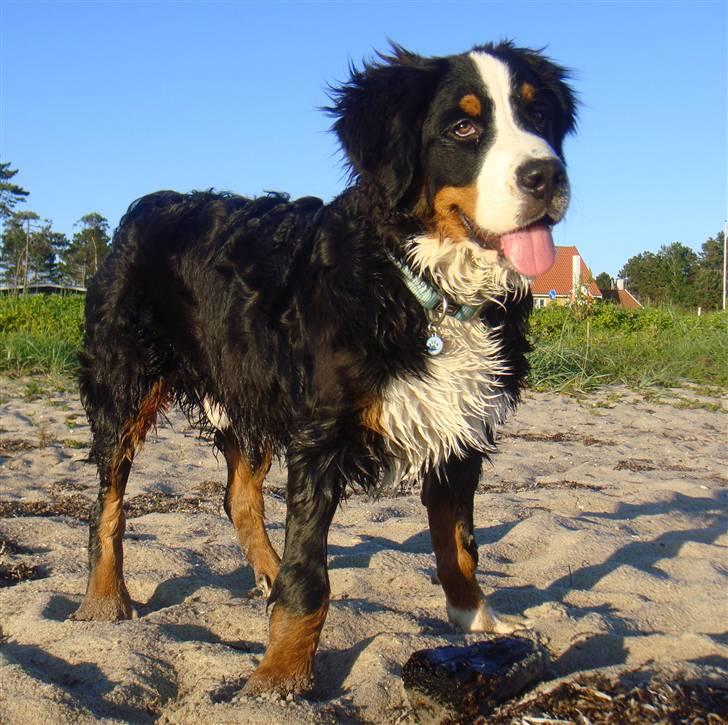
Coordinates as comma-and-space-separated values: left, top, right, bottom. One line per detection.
379, 317, 514, 478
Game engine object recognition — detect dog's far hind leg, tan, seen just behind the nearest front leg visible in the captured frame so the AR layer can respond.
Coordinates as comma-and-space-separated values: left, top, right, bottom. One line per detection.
218, 431, 281, 597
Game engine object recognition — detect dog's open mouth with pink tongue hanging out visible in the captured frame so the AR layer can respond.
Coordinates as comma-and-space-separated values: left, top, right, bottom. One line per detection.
458, 211, 556, 277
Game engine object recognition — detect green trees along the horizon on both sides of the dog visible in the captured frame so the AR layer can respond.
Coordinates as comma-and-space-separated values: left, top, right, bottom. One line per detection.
0, 163, 723, 310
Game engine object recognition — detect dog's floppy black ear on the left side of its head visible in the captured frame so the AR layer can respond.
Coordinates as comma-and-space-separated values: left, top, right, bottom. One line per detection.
326, 46, 446, 209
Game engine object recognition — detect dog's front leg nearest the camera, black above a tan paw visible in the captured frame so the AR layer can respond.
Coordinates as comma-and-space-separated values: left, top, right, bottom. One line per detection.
245, 430, 343, 694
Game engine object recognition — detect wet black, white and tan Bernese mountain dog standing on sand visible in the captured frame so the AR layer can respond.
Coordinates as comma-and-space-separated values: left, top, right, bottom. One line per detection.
74, 42, 576, 693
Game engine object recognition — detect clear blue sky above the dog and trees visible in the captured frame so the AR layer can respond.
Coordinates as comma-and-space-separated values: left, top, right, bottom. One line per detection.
0, 0, 728, 275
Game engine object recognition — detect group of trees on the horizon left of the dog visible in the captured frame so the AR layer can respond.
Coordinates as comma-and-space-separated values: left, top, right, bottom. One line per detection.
0, 162, 111, 288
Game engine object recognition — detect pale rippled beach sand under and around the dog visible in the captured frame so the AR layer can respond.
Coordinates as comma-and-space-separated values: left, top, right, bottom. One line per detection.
0, 379, 728, 723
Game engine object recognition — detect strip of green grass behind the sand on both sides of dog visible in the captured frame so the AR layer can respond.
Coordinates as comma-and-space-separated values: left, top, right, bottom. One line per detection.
0, 295, 728, 394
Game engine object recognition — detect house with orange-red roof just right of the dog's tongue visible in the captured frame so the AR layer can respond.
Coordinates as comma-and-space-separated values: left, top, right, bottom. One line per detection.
531, 247, 603, 307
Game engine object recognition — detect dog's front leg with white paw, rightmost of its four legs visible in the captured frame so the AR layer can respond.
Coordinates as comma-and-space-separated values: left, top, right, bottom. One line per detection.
422, 454, 522, 634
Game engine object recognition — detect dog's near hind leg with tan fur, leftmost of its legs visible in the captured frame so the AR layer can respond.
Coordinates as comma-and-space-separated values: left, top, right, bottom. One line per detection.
72, 380, 169, 621
